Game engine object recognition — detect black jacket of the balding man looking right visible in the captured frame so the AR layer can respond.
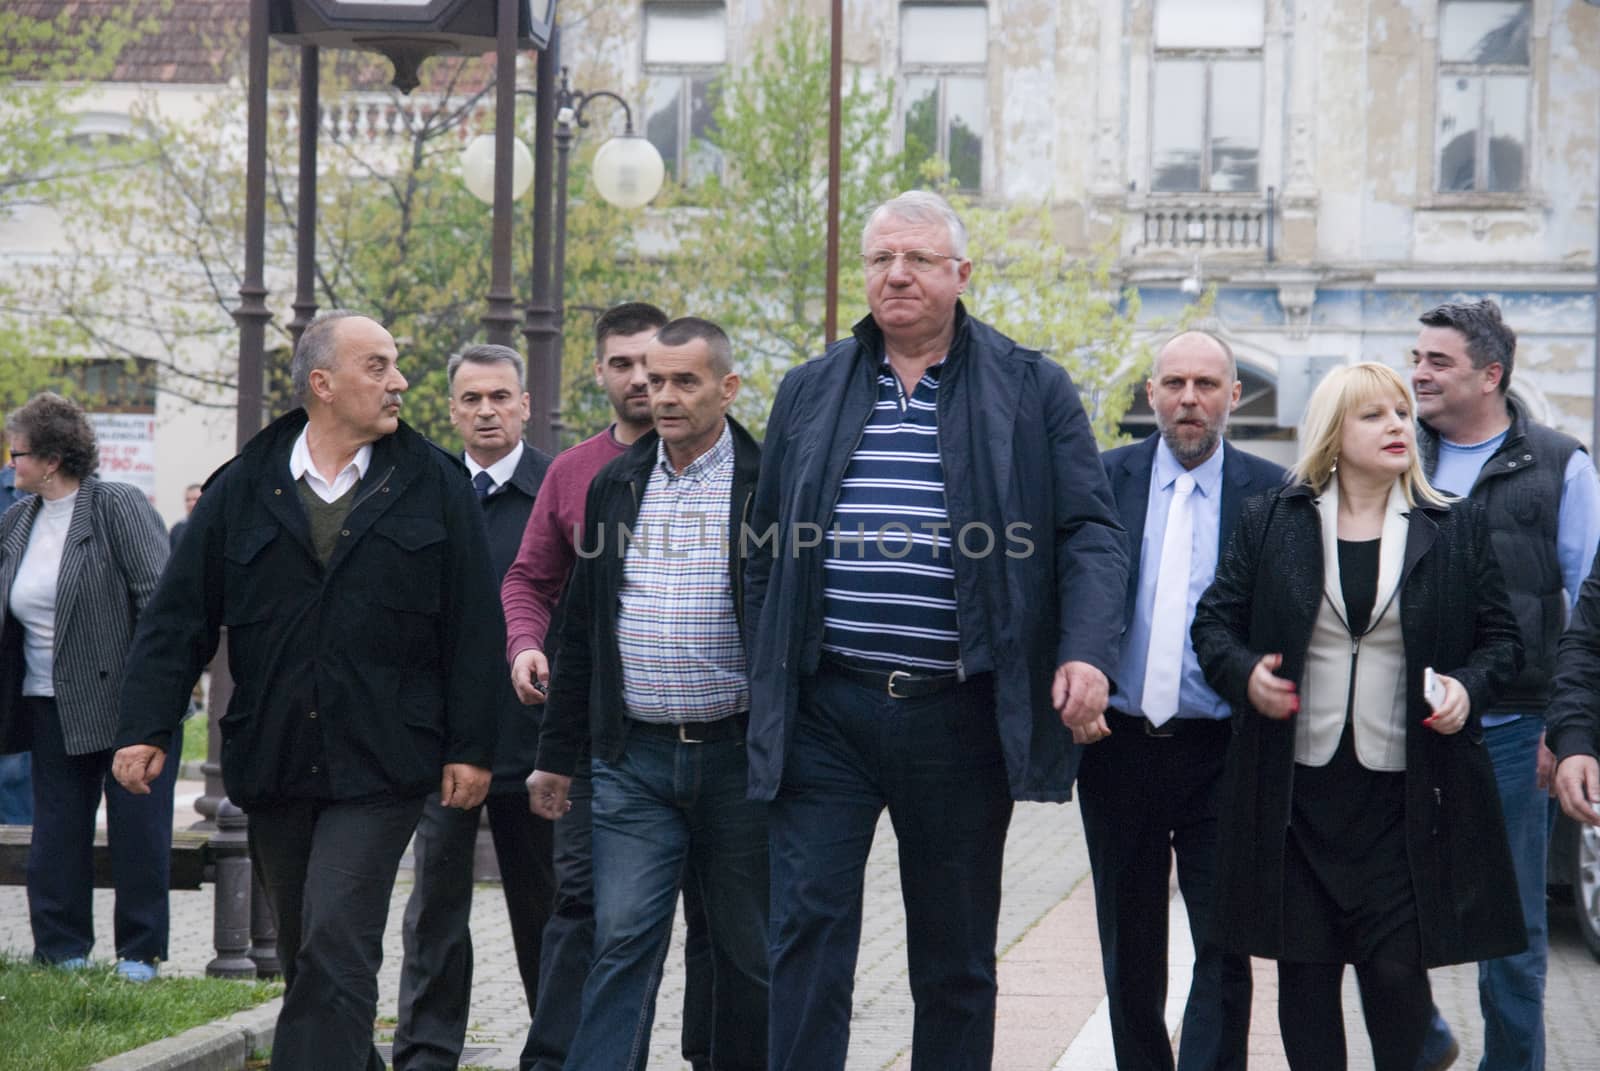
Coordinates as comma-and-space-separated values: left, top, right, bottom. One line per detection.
117, 410, 506, 810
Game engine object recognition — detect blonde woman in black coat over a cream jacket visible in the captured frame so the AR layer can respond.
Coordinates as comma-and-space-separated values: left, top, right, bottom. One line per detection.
1194, 363, 1525, 1071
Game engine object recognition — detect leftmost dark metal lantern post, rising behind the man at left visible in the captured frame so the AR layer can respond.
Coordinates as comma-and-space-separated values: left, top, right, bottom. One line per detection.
234, 0, 272, 448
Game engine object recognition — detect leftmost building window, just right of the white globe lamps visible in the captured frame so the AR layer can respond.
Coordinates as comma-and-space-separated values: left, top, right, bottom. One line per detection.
645, 3, 728, 186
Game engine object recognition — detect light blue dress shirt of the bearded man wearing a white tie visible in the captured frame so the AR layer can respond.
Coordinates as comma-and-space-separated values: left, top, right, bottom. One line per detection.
1110, 440, 1229, 719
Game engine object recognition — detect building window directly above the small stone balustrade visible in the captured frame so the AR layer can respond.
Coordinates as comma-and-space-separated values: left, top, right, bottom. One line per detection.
1150, 0, 1266, 194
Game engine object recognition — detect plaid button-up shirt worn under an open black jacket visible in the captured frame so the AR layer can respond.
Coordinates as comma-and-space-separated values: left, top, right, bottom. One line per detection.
616, 423, 750, 722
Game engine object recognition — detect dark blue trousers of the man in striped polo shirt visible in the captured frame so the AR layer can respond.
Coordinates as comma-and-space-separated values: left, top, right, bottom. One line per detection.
770, 666, 1011, 1071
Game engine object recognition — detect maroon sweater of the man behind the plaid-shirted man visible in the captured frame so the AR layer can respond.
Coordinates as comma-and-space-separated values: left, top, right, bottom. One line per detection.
501, 424, 627, 663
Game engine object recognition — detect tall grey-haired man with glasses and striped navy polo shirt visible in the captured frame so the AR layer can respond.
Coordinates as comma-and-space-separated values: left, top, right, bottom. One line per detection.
746, 192, 1128, 1071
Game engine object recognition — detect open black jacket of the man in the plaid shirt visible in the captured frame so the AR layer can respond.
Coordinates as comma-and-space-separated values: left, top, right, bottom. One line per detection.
539, 416, 762, 775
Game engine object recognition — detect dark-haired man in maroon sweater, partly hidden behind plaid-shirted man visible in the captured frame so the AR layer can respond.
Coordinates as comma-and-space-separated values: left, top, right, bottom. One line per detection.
501, 301, 712, 1071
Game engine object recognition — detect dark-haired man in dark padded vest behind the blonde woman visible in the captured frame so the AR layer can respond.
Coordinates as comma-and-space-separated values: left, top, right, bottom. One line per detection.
1411, 301, 1600, 1071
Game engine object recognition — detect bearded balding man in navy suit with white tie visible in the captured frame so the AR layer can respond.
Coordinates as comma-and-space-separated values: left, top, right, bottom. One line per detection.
1078, 331, 1285, 1071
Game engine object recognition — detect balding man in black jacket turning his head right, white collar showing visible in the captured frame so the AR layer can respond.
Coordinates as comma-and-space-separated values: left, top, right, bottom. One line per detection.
112, 312, 504, 1071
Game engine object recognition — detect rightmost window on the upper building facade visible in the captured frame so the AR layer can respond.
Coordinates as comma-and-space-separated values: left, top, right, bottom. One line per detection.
1438, 0, 1533, 194
